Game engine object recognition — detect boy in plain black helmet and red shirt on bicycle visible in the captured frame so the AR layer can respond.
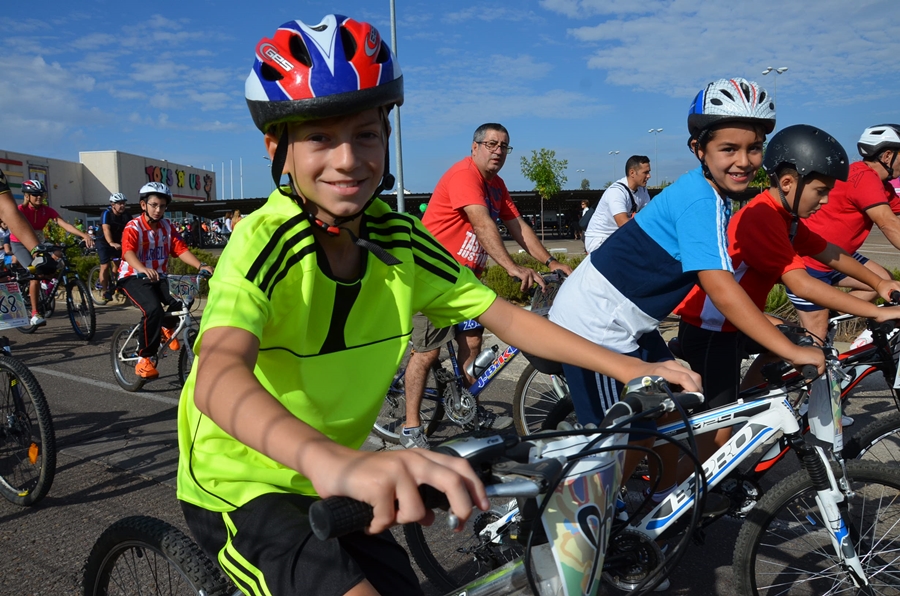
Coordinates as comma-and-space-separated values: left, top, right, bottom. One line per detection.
675, 124, 900, 460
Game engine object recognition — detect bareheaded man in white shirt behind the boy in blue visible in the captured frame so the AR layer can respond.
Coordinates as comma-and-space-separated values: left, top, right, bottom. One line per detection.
584, 155, 650, 253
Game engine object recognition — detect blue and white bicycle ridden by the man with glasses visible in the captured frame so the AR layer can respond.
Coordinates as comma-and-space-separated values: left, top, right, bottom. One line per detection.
373, 273, 562, 444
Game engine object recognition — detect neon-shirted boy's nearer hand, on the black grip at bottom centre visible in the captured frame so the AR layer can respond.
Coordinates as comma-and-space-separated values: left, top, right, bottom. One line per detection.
307, 445, 490, 534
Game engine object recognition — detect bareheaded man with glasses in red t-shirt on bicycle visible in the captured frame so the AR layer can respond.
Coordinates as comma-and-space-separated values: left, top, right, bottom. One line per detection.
401, 123, 572, 449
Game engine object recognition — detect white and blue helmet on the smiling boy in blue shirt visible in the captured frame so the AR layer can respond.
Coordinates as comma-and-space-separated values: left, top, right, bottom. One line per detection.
688, 78, 775, 140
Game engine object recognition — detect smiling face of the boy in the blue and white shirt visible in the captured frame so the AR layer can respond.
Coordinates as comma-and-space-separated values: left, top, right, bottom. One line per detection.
699, 122, 763, 192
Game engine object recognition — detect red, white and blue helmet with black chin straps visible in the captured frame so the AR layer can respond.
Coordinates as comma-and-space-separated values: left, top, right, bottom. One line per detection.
244, 14, 403, 260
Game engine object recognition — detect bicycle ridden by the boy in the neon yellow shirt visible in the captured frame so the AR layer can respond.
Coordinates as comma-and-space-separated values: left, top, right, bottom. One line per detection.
83, 379, 703, 596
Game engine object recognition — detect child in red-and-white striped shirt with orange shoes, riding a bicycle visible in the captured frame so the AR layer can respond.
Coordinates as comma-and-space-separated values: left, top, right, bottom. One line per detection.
119, 182, 213, 379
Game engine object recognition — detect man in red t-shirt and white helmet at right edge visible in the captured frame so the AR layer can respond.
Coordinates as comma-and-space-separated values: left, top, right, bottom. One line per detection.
788, 124, 900, 338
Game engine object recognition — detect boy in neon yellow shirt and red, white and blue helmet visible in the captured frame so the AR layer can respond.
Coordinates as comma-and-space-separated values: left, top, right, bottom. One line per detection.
172, 15, 696, 595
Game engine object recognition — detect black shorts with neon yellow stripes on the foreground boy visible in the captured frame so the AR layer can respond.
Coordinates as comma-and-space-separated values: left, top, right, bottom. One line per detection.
181, 493, 422, 596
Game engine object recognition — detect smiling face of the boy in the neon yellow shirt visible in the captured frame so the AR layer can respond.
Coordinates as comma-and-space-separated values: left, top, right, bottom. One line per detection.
266, 109, 388, 223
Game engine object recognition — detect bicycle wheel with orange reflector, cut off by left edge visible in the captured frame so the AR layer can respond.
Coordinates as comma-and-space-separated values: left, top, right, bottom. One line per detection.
0, 355, 56, 506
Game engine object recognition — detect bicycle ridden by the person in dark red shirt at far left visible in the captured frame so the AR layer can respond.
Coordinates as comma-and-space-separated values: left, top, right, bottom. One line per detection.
17, 245, 97, 341
